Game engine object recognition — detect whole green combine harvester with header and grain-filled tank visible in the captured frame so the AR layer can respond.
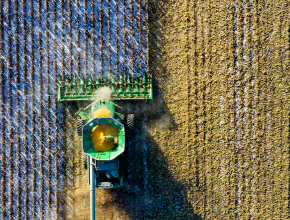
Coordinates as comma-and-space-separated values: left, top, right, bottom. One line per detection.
58, 74, 152, 219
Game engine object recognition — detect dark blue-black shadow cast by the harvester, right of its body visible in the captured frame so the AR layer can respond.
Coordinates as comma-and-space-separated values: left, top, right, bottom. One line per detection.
112, 85, 201, 220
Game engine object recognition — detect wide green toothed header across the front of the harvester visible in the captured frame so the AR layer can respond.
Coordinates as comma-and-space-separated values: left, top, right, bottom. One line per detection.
58, 74, 152, 102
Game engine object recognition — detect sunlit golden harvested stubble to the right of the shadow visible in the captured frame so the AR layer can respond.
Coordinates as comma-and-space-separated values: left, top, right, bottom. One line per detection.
149, 1, 289, 219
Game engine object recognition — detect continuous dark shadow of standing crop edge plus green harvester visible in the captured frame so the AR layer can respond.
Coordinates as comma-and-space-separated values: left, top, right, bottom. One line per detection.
112, 0, 201, 214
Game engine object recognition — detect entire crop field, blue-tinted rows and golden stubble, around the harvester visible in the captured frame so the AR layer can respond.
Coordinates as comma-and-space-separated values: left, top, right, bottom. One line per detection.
0, 0, 290, 220
